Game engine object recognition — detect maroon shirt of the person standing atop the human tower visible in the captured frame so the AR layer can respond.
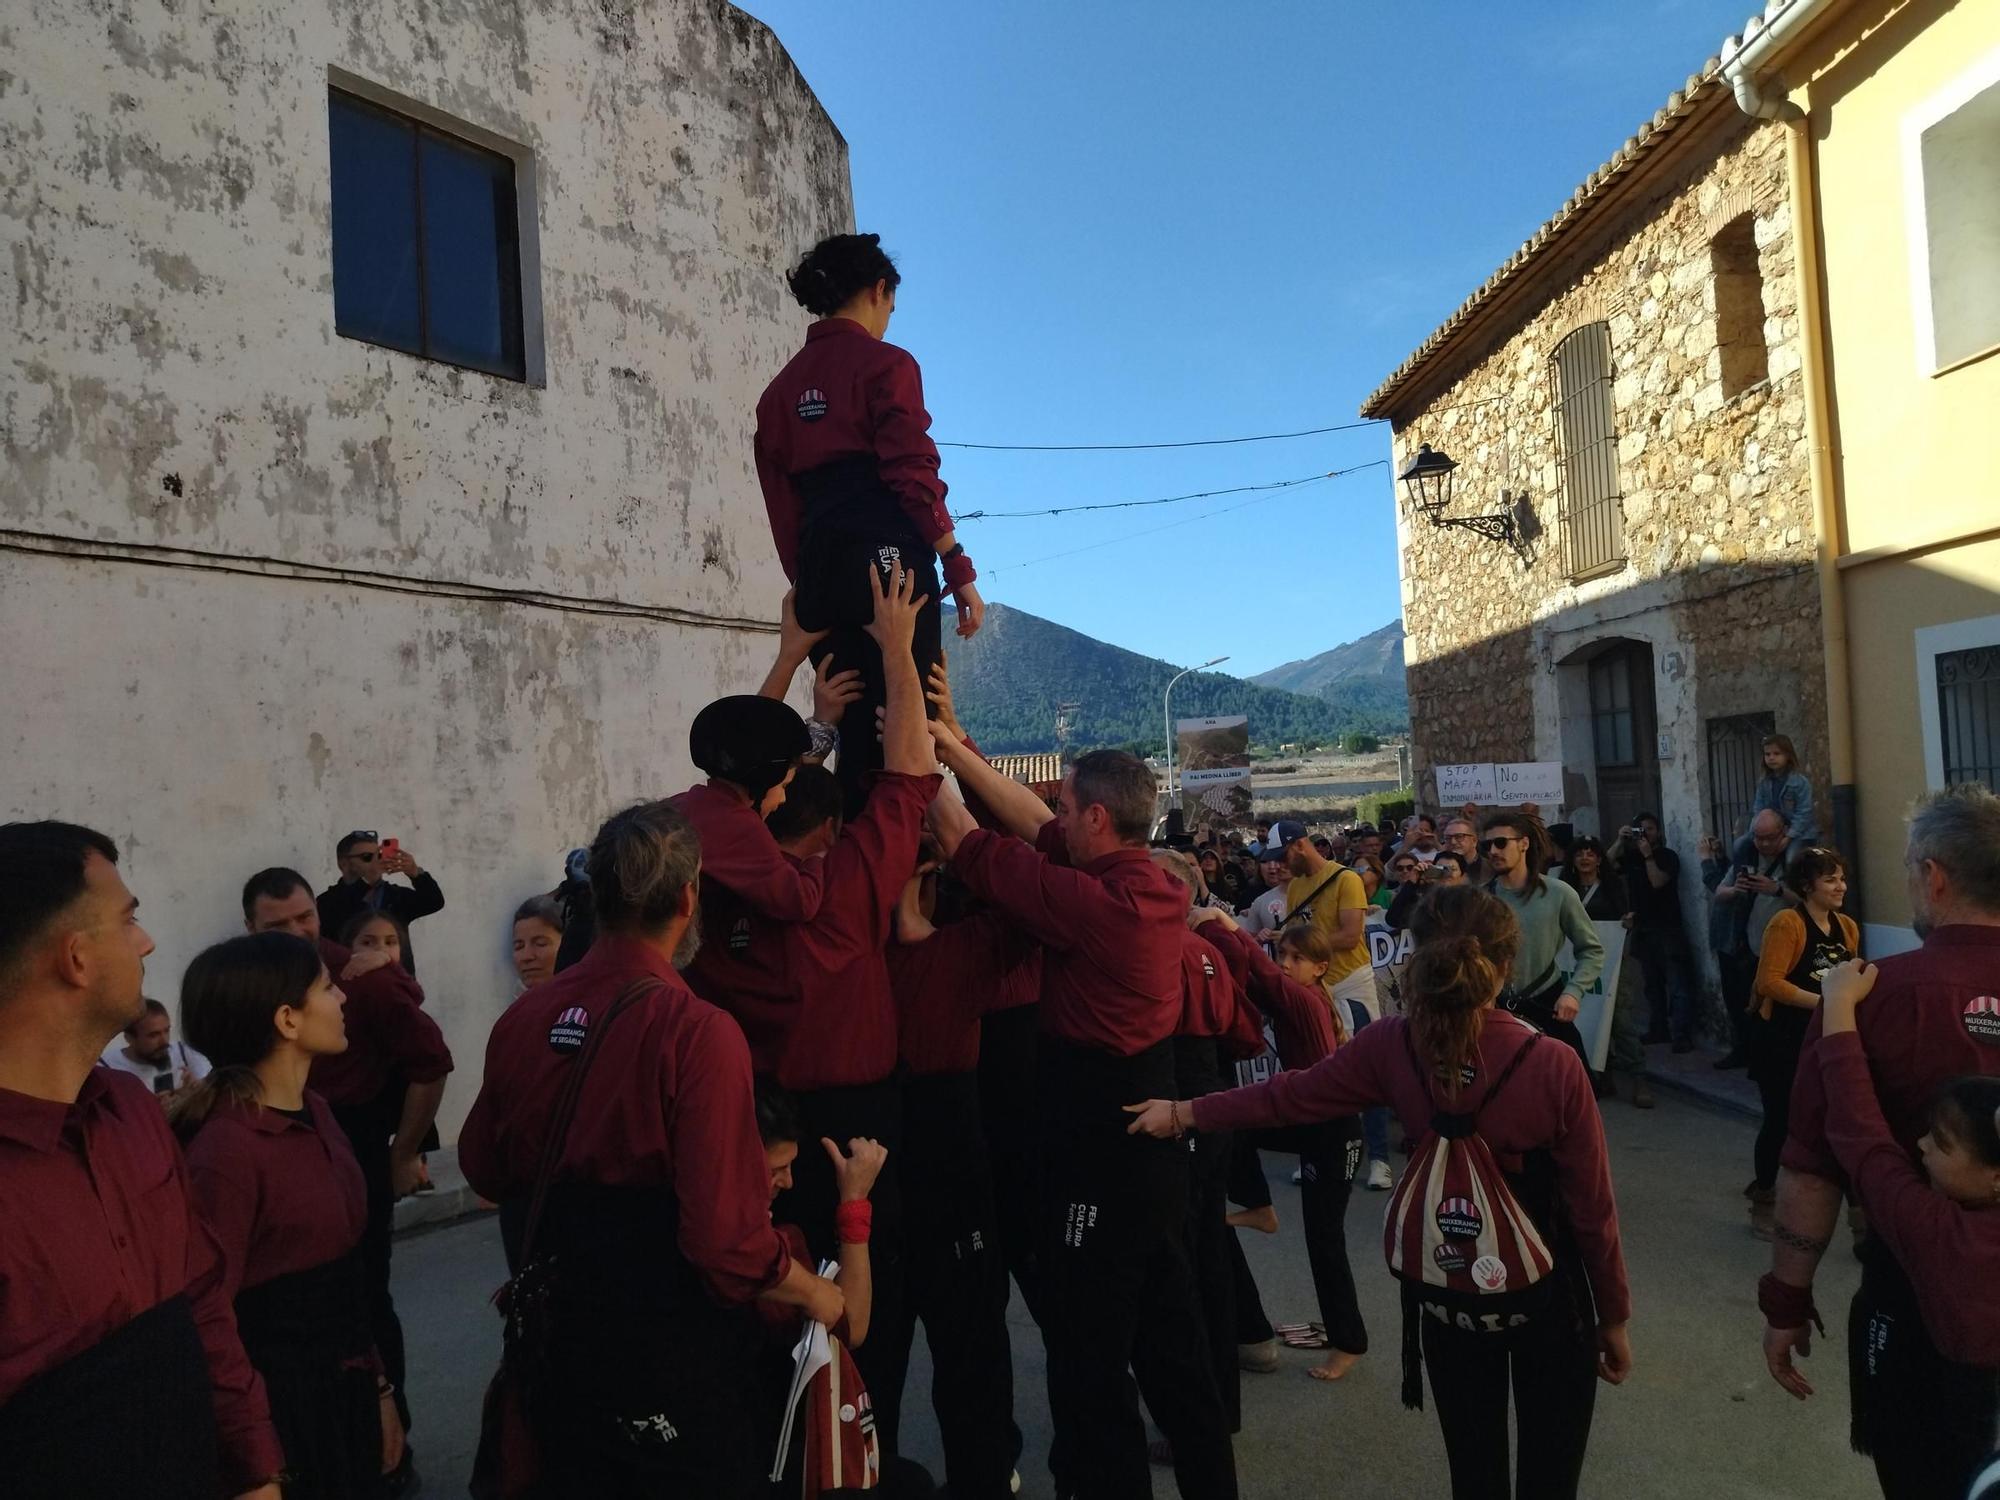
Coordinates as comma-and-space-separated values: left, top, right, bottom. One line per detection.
756, 318, 952, 582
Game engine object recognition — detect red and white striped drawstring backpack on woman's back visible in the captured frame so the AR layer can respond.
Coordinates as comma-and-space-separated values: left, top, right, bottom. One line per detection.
1382, 1028, 1556, 1410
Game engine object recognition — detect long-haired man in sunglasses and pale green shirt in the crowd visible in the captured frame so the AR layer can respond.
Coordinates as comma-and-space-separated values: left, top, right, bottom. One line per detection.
1480, 812, 1604, 1072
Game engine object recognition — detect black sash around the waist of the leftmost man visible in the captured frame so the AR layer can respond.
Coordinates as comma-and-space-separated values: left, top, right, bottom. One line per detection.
0, 1296, 222, 1500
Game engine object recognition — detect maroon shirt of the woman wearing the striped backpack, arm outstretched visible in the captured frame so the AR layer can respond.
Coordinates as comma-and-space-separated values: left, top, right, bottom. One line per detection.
1192, 1010, 1632, 1324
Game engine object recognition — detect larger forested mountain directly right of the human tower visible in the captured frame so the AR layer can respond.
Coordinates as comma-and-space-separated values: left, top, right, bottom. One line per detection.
944, 604, 1410, 754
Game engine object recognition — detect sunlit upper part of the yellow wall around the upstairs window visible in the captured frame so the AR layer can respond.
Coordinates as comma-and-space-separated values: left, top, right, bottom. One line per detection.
1816, 0, 2000, 556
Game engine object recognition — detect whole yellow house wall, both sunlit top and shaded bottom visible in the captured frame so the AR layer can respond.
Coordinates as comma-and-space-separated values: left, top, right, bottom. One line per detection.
1786, 0, 2000, 940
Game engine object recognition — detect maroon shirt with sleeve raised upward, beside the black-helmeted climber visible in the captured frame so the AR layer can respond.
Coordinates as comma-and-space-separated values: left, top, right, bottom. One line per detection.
698, 772, 942, 1090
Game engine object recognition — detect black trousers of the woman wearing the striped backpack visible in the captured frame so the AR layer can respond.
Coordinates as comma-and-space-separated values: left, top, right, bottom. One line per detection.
1418, 1296, 1598, 1500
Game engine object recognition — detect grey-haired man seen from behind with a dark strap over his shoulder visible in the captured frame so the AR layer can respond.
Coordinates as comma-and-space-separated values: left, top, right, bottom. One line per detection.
458, 802, 844, 1500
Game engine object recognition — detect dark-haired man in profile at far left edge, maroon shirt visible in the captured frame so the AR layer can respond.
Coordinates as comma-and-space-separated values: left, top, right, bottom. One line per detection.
0, 822, 284, 1500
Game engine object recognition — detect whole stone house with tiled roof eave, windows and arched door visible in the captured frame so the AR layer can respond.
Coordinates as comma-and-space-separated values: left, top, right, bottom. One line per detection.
1362, 64, 1826, 1000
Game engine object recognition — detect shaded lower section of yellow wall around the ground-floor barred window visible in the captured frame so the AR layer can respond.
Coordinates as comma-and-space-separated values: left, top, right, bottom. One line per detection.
1846, 538, 2000, 926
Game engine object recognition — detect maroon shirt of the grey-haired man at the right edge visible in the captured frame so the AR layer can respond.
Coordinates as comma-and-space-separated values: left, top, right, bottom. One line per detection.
1782, 926, 2000, 1182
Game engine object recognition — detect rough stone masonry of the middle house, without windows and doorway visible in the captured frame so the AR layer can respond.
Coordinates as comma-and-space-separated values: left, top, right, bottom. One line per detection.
1394, 111, 1826, 1004
